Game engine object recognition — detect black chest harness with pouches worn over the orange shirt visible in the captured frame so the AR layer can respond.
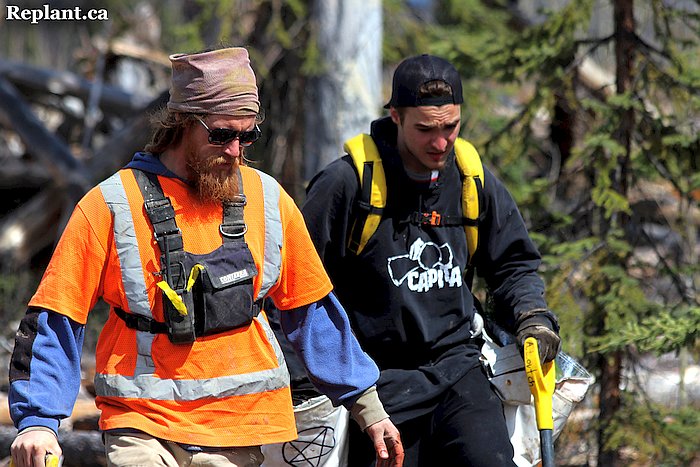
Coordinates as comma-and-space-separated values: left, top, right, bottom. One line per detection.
115, 170, 260, 344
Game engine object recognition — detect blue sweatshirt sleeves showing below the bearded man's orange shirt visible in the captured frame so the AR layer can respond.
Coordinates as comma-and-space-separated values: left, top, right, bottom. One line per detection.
9, 293, 379, 433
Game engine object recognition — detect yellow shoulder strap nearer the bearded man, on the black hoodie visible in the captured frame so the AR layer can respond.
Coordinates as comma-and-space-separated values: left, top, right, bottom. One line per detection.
344, 133, 387, 254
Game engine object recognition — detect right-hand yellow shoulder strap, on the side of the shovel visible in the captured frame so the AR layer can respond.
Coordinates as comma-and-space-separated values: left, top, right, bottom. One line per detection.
455, 138, 484, 263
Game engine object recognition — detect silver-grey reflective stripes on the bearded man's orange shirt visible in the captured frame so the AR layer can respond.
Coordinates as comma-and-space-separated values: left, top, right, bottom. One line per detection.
95, 170, 289, 401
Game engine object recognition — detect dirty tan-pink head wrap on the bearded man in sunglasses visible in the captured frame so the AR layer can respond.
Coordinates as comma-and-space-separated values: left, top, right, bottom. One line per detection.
168, 47, 260, 116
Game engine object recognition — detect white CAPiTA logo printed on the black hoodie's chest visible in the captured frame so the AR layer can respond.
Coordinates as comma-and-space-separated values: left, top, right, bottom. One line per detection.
387, 238, 462, 292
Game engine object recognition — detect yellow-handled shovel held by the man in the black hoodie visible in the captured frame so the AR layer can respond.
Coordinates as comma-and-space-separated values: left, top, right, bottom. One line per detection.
523, 337, 556, 467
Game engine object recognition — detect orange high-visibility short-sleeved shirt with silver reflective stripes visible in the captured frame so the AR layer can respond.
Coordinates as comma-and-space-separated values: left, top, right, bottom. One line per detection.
30, 167, 332, 446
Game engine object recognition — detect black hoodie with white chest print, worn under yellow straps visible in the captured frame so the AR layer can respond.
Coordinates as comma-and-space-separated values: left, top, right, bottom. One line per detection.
302, 117, 546, 423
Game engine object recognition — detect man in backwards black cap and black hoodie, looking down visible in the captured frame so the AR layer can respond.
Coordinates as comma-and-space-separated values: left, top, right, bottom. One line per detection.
302, 55, 559, 467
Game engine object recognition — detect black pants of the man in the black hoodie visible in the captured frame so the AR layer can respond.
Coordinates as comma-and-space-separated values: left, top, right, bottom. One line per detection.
348, 366, 515, 467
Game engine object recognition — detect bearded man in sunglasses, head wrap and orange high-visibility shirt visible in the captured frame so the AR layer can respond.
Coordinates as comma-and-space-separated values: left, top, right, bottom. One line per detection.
9, 48, 403, 467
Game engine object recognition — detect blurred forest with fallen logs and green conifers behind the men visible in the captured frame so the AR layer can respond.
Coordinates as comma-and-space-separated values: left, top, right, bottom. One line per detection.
0, 0, 700, 466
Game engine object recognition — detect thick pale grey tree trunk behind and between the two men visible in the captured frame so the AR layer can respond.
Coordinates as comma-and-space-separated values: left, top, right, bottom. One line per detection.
304, 0, 383, 184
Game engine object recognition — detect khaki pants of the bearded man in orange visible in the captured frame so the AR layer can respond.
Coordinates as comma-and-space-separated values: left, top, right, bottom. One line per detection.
105, 433, 263, 467
